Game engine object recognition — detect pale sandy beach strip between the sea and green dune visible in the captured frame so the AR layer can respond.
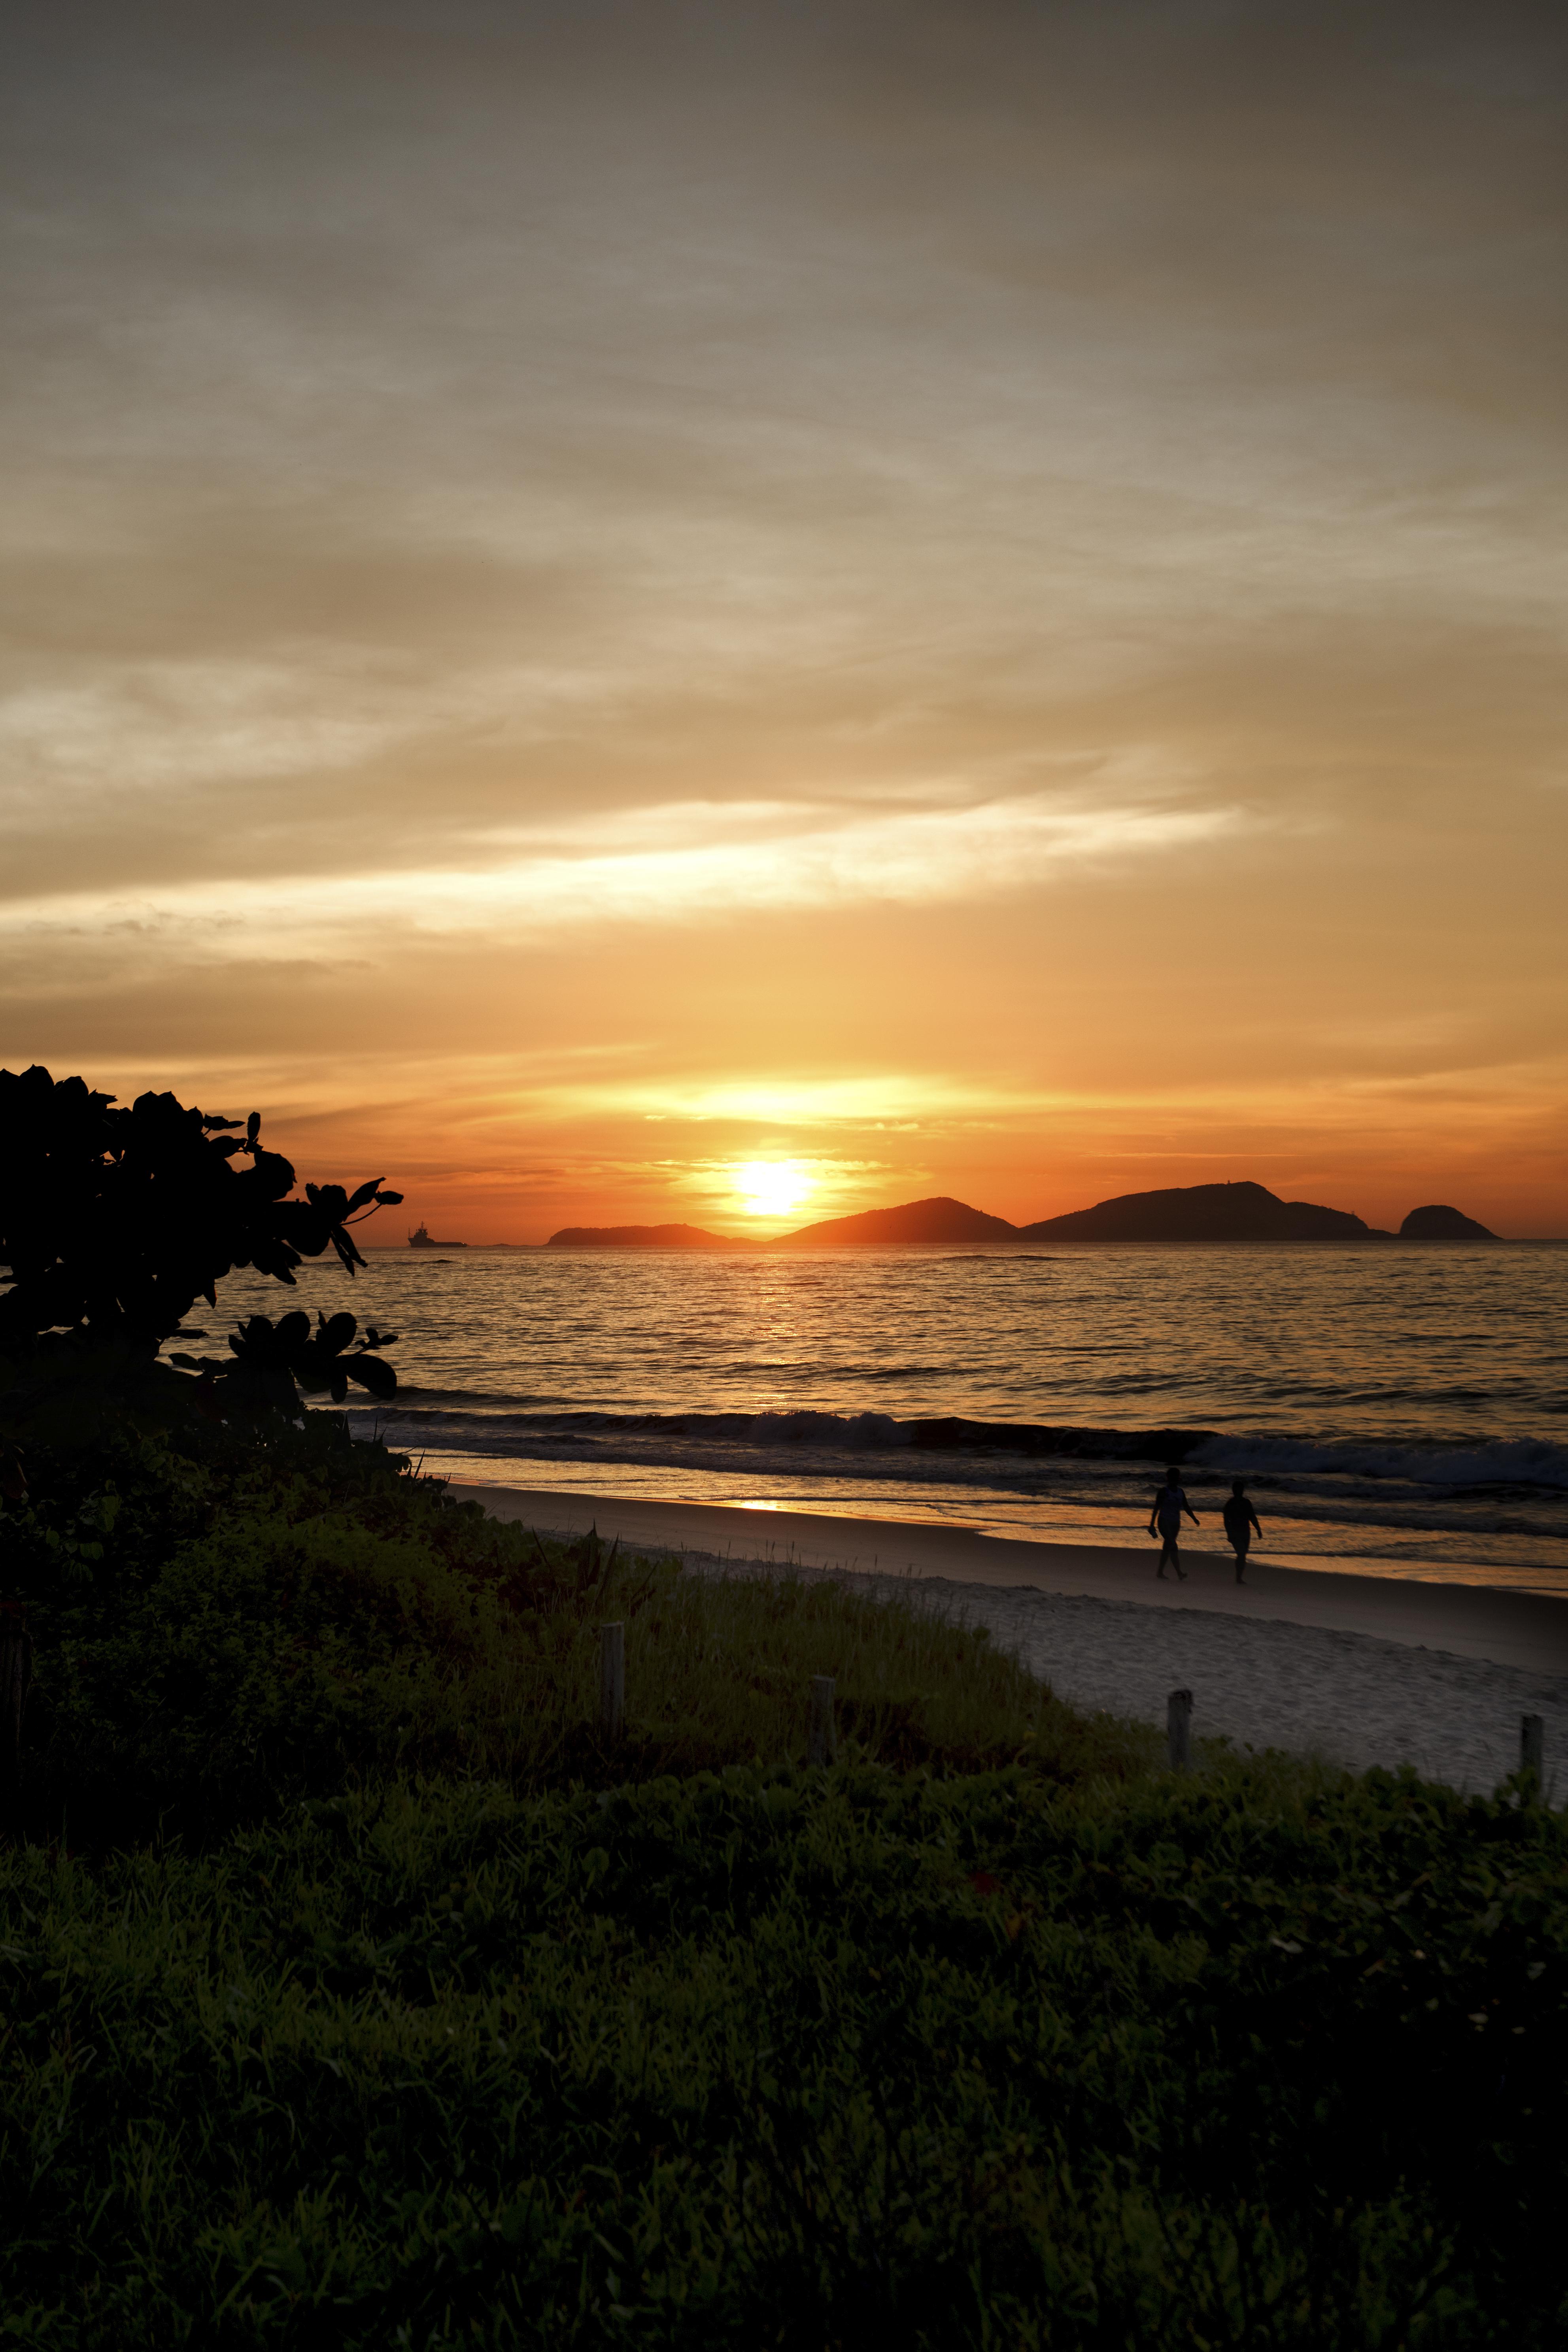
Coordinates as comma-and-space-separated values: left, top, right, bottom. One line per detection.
454, 1484, 1568, 1790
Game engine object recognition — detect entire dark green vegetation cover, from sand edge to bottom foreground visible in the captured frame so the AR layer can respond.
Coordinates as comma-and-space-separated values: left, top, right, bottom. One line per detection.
0, 1427, 1568, 2352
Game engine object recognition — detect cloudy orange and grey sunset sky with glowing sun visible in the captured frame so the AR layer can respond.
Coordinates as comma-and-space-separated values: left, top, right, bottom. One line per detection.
0, 0, 1568, 1242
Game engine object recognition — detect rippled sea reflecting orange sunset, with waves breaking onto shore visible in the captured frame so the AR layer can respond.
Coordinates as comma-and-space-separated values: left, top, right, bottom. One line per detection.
207, 1242, 1568, 1592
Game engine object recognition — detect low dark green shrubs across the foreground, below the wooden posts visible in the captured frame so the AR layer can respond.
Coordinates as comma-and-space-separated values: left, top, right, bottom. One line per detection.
0, 1764, 1568, 2352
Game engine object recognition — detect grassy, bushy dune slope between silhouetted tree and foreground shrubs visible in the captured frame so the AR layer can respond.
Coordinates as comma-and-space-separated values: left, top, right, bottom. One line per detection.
0, 1411, 1081, 1853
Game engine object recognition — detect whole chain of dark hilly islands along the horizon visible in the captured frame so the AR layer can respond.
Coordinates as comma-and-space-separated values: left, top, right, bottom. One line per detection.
545, 1181, 1498, 1249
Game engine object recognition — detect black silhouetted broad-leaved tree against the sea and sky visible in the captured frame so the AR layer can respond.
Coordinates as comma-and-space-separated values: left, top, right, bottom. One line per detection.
0, 1065, 402, 1414
